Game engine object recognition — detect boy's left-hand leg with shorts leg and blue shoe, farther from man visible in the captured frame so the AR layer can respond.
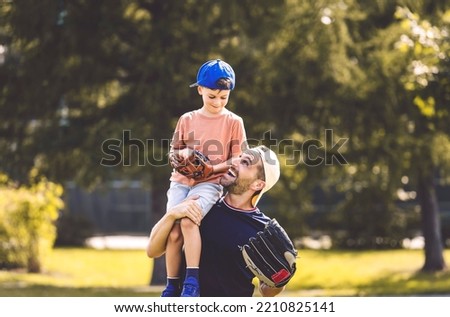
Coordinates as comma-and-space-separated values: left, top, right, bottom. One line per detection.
161, 182, 189, 297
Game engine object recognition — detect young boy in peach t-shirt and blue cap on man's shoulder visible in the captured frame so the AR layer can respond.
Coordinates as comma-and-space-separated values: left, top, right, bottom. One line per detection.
161, 59, 247, 297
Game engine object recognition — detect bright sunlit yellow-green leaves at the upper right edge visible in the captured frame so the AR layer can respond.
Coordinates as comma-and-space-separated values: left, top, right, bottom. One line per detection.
396, 7, 450, 173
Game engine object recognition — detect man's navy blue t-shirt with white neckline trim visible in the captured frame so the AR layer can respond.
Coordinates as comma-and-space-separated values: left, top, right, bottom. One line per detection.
200, 198, 270, 297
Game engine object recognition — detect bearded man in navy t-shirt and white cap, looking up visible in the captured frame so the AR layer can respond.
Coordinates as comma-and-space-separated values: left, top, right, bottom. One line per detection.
147, 146, 284, 297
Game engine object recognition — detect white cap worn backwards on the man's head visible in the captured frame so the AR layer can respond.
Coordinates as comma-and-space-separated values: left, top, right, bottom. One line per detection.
250, 146, 280, 207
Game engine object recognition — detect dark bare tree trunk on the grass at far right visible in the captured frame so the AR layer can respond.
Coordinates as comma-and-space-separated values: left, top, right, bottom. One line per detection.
418, 169, 446, 272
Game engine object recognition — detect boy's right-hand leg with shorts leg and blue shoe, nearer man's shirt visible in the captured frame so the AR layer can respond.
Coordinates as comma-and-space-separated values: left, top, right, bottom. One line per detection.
181, 183, 222, 297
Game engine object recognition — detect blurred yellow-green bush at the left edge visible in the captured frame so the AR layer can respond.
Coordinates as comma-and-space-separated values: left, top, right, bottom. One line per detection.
0, 174, 63, 272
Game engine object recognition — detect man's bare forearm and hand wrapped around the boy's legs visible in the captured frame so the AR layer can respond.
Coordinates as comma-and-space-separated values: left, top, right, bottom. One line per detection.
146, 196, 202, 258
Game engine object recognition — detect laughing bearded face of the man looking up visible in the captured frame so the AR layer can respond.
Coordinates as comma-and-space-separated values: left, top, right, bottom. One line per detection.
220, 151, 262, 194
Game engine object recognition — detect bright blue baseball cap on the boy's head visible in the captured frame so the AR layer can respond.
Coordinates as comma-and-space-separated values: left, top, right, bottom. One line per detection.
189, 59, 235, 90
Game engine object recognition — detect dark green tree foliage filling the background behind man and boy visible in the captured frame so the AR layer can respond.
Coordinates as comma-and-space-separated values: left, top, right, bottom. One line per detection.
0, 0, 450, 270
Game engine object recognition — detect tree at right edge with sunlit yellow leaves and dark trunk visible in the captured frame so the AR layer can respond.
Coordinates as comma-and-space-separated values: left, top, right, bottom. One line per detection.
396, 7, 450, 271
